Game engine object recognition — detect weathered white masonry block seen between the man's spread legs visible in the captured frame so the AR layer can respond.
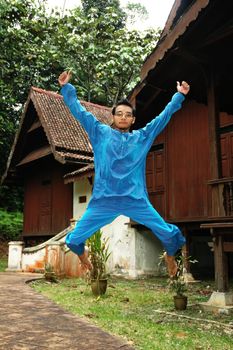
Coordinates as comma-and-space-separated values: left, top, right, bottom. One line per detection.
102, 215, 166, 278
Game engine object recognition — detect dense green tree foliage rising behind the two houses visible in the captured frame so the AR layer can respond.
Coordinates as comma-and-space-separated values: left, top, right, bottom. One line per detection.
0, 0, 159, 207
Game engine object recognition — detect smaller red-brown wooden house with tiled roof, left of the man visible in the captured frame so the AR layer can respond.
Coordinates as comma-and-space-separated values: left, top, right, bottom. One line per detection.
3, 87, 111, 246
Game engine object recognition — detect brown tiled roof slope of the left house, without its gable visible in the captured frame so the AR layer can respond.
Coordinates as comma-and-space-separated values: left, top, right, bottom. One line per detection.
30, 87, 112, 156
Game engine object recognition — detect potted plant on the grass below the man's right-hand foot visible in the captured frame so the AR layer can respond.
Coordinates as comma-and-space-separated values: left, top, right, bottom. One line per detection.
169, 254, 197, 310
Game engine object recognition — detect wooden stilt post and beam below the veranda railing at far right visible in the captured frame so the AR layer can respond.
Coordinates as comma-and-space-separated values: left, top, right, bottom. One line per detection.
200, 222, 233, 292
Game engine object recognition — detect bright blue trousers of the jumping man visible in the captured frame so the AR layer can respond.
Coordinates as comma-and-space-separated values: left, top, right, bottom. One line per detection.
66, 197, 185, 255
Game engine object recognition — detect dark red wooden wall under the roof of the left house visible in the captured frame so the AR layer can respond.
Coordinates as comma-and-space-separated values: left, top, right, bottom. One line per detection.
23, 161, 73, 236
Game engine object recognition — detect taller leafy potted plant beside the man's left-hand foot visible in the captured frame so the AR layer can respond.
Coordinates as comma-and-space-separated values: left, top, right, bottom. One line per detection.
87, 230, 111, 296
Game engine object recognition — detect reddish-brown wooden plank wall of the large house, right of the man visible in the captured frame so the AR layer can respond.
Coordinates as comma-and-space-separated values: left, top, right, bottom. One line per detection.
147, 102, 209, 221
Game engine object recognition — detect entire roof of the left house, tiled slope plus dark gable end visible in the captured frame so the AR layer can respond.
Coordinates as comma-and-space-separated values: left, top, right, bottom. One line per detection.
2, 87, 112, 181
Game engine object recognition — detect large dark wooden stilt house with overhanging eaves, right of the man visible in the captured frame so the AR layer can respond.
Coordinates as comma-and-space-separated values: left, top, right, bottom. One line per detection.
130, 0, 233, 290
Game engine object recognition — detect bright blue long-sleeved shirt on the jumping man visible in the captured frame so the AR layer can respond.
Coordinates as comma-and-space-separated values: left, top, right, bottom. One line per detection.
61, 84, 184, 199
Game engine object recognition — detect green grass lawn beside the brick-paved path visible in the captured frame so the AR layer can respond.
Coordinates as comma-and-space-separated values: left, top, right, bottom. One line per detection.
32, 278, 233, 350
